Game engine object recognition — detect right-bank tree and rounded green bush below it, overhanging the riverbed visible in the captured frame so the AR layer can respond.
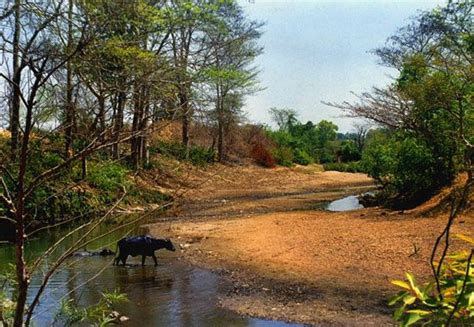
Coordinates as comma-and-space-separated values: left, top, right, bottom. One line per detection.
356, 1, 474, 206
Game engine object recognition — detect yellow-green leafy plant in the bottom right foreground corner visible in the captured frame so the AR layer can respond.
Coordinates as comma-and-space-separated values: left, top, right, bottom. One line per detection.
388, 235, 474, 326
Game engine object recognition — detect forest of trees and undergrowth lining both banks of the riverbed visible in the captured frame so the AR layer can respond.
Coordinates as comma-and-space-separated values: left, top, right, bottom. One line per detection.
0, 0, 474, 326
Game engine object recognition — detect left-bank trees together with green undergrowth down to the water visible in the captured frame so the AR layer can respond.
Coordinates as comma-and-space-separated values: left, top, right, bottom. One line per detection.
0, 0, 262, 237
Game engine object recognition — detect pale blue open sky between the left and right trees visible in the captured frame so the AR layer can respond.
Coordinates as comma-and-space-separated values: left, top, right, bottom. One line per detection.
240, 0, 445, 132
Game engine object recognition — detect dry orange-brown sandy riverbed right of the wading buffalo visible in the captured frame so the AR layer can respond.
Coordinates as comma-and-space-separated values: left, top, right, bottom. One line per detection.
148, 166, 474, 326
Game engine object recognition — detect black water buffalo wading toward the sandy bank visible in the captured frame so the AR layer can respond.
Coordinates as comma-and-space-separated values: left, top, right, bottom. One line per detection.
114, 235, 176, 266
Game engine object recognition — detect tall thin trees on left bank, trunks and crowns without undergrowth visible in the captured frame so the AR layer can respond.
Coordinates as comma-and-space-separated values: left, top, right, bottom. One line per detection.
0, 0, 262, 167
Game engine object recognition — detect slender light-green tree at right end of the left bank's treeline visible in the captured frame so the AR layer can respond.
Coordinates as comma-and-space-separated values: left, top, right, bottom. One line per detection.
203, 2, 262, 161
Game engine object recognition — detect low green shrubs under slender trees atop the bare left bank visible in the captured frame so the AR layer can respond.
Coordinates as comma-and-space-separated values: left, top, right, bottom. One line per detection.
152, 141, 216, 166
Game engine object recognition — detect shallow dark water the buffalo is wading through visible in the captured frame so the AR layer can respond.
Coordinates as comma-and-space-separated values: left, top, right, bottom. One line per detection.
0, 218, 298, 327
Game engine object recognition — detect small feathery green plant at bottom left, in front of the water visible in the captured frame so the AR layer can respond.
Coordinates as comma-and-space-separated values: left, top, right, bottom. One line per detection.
55, 290, 128, 326
